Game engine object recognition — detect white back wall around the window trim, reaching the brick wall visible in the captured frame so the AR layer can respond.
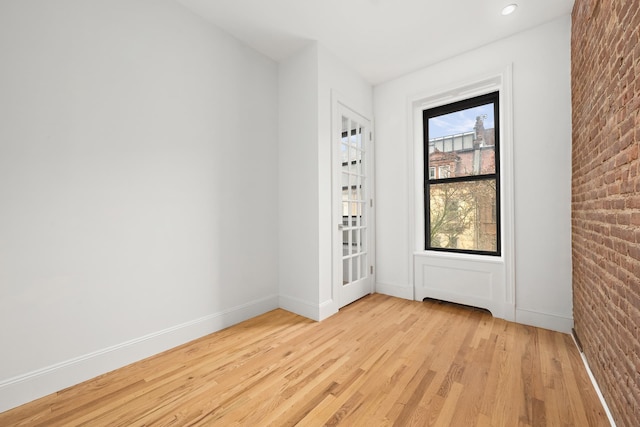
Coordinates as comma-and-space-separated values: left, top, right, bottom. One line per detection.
374, 16, 572, 332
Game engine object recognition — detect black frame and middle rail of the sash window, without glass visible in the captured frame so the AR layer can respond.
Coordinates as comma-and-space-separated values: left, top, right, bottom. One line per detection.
422, 91, 502, 256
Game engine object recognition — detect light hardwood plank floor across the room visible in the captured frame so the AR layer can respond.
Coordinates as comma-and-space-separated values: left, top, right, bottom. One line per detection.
0, 294, 609, 427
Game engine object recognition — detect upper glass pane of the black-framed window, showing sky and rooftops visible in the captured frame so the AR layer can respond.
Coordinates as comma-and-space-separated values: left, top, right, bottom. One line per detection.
428, 103, 496, 179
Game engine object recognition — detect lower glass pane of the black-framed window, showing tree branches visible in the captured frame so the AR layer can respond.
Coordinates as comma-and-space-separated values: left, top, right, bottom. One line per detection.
429, 179, 498, 252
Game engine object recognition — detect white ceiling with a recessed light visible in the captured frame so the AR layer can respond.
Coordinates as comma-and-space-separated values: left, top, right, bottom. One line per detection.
178, 0, 574, 84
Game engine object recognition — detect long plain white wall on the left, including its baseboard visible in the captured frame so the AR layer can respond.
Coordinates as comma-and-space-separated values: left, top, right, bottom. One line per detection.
0, 0, 280, 411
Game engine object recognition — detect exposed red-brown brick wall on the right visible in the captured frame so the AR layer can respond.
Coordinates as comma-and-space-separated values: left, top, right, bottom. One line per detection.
572, 0, 640, 427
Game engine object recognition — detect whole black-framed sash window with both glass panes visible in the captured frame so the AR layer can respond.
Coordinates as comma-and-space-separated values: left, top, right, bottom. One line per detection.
423, 92, 500, 255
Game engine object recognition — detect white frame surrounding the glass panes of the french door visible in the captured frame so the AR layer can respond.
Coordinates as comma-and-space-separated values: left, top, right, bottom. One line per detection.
331, 92, 376, 310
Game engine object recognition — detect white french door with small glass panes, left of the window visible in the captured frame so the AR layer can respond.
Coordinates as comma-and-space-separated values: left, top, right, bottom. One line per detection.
333, 103, 375, 307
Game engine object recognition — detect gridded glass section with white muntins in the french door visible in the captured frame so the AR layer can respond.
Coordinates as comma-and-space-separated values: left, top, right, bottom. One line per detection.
340, 116, 368, 286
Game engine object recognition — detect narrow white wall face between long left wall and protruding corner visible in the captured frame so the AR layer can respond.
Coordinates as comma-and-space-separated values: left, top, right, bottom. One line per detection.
278, 44, 319, 320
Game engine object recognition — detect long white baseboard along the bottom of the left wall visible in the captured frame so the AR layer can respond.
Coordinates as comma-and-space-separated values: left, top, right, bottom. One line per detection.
0, 295, 278, 412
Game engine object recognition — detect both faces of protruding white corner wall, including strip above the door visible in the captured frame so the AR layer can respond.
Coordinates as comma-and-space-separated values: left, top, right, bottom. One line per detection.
279, 42, 373, 320
